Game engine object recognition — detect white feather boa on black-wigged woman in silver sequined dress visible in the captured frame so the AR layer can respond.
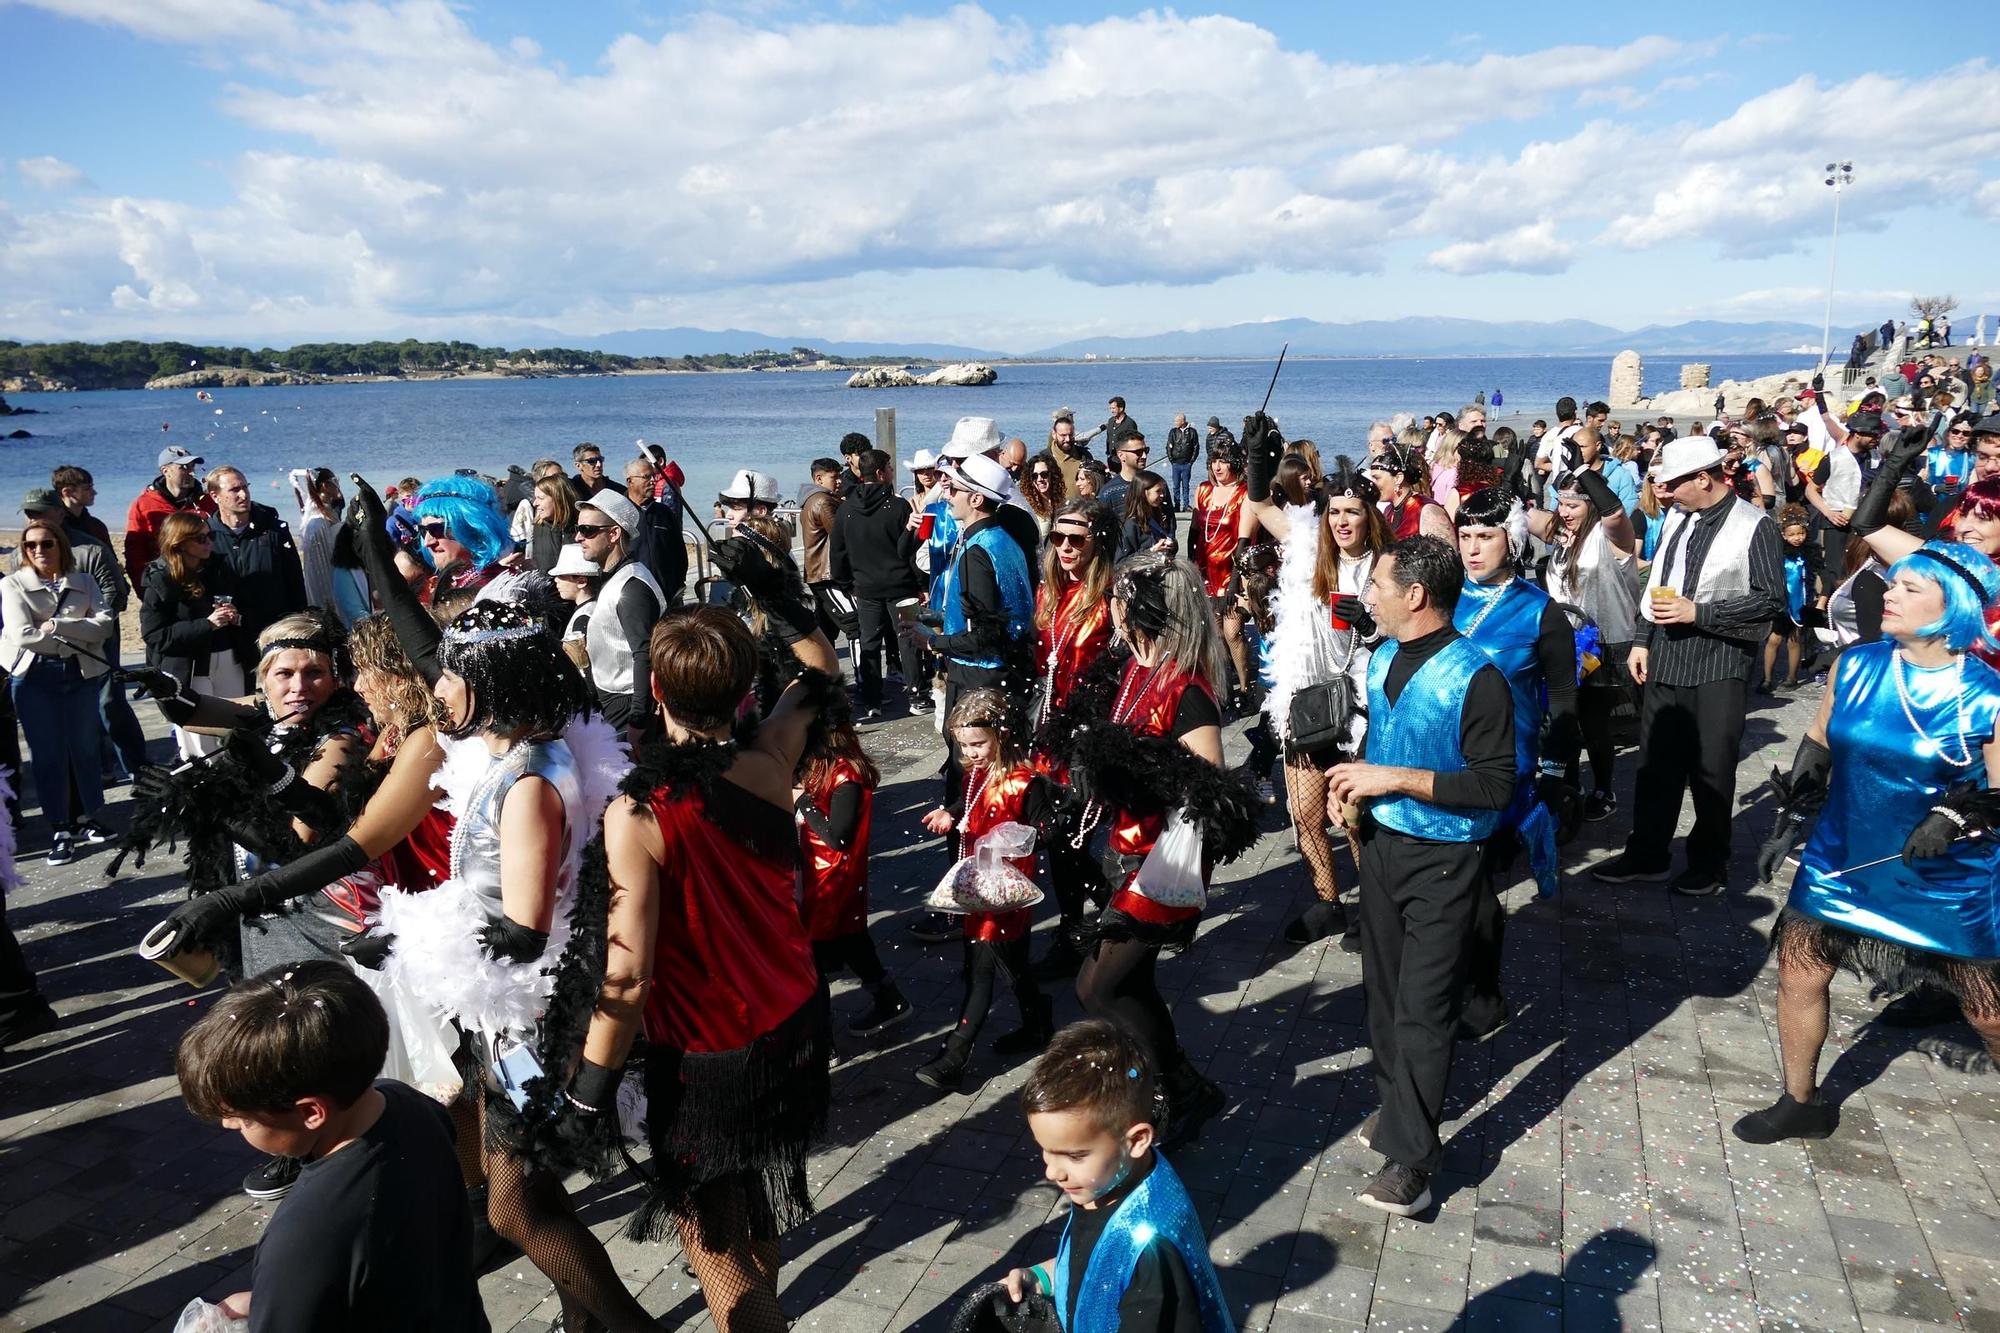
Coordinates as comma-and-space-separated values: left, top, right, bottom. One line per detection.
382, 717, 632, 1039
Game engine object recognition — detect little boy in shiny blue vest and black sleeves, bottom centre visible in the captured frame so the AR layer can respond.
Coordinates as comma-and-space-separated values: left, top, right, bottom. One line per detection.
988, 1021, 1234, 1333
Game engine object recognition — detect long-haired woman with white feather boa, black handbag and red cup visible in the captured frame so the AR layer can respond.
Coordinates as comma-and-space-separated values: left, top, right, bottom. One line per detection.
1264, 458, 1388, 951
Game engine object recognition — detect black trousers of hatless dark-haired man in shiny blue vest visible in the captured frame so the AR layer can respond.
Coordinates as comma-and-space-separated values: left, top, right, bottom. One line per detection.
1360, 829, 1490, 1171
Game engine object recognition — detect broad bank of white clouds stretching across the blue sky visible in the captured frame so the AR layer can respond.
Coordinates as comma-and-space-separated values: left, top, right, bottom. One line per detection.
0, 0, 2000, 342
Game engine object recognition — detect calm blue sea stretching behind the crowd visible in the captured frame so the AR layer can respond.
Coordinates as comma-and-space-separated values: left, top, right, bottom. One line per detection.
0, 356, 1804, 528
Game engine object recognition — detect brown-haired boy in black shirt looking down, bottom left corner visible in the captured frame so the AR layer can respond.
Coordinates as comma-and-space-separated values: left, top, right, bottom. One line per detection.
174, 961, 488, 1333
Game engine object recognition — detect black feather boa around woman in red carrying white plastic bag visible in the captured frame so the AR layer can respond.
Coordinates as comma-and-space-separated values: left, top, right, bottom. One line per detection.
1036, 646, 1258, 865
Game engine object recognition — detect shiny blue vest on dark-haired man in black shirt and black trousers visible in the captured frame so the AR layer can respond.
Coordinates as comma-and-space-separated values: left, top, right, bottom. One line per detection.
1368, 638, 1500, 843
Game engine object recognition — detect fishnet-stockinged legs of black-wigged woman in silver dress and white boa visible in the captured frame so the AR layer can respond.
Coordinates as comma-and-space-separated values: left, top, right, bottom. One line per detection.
452, 1089, 656, 1333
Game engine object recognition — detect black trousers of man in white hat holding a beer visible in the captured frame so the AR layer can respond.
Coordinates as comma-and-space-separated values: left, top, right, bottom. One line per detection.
1626, 681, 1748, 879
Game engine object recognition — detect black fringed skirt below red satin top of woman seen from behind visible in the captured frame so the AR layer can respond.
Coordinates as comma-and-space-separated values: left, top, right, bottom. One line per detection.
630, 995, 832, 1245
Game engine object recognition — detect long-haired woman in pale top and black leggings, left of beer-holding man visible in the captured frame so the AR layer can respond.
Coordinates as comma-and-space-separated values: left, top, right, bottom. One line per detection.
1528, 468, 1638, 821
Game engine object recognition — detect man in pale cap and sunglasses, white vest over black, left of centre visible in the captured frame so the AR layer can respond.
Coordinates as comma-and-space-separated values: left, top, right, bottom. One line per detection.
576, 490, 666, 739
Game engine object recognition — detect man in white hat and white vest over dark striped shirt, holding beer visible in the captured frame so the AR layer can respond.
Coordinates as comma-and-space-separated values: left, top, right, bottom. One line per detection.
1594, 434, 1786, 897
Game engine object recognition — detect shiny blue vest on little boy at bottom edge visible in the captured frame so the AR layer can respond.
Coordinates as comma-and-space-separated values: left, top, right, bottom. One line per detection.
1052, 1149, 1236, 1333
